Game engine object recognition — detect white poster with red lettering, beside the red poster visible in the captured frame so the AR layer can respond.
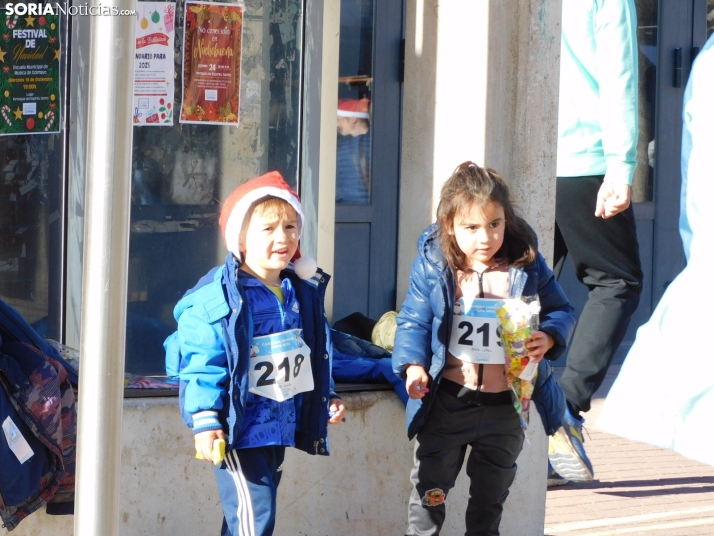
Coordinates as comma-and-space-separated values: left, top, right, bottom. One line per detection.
134, 2, 176, 126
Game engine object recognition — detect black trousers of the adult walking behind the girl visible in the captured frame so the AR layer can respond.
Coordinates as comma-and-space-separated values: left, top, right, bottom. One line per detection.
553, 176, 642, 413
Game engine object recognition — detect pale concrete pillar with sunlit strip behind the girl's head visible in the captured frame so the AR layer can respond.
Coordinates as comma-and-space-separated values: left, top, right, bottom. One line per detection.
397, 0, 561, 306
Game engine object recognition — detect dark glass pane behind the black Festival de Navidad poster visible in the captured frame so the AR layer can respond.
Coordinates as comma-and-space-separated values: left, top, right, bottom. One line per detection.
0, 8, 67, 340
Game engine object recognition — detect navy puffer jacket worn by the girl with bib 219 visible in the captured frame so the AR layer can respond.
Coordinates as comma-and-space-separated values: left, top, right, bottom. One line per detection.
392, 225, 576, 439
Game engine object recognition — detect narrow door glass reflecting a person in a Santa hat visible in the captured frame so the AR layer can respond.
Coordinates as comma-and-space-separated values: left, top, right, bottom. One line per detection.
336, 0, 374, 205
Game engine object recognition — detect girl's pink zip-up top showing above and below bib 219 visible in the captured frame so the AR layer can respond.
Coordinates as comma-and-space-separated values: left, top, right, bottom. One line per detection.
443, 259, 508, 393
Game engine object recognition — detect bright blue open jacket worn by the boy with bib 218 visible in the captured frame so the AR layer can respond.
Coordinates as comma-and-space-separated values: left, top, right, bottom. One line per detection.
164, 253, 338, 455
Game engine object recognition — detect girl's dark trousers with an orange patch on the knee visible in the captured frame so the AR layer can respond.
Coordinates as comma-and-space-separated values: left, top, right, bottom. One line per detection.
407, 391, 524, 536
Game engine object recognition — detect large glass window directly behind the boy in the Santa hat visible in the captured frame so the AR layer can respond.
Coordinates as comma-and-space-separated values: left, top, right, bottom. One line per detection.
126, 0, 303, 374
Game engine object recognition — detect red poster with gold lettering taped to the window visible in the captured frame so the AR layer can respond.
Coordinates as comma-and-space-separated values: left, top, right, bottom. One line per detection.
179, 2, 244, 125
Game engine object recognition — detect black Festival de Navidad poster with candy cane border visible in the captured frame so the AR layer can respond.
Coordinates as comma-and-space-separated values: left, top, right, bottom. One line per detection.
0, 9, 61, 135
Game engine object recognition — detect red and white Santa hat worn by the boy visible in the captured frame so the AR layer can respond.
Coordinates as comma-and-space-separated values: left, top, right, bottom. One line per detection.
218, 171, 317, 279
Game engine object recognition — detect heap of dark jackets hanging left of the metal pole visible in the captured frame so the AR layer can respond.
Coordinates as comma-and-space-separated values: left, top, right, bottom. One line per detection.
0, 300, 77, 531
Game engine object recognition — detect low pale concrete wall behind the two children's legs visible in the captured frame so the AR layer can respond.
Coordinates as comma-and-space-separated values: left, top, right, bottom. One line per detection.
0, 391, 547, 536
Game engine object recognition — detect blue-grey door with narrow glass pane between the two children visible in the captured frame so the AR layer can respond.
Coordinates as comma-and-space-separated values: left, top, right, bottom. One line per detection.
332, 0, 403, 320
